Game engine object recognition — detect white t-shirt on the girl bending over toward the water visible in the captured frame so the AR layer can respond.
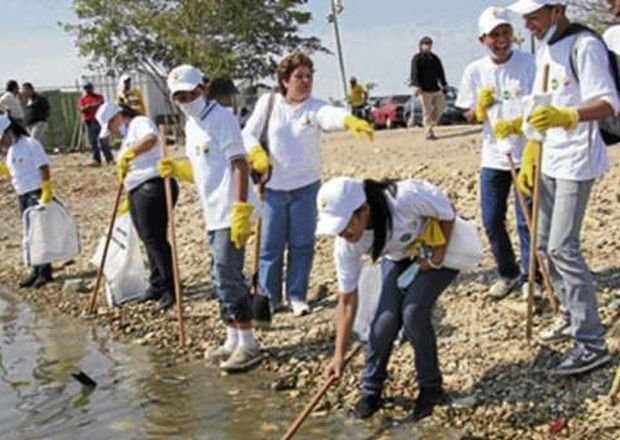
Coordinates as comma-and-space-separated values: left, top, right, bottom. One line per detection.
334, 179, 455, 293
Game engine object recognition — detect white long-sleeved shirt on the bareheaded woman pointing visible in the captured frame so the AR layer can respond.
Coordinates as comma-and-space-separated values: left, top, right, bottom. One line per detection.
243, 93, 348, 191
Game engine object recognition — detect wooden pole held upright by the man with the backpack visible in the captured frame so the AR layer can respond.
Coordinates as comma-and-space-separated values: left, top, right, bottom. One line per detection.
525, 64, 549, 341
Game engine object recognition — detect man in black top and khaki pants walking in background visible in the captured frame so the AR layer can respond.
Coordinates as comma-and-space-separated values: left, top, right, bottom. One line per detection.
409, 37, 448, 140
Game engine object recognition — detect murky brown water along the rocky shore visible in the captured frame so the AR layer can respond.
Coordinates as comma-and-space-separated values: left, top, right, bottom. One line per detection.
0, 292, 454, 440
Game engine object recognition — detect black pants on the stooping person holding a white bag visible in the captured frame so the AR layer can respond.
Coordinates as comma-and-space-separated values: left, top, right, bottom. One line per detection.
129, 177, 179, 296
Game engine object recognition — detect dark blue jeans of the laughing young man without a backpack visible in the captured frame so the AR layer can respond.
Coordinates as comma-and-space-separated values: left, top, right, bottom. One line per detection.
480, 168, 531, 278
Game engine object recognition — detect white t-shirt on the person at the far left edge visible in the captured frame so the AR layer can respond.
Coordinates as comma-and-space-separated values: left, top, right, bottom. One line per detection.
6, 136, 50, 195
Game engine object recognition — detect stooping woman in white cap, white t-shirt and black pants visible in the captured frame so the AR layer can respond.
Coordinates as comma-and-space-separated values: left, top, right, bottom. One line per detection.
96, 102, 179, 310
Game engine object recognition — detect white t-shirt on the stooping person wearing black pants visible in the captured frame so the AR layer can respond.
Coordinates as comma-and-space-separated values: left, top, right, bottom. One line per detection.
120, 116, 161, 191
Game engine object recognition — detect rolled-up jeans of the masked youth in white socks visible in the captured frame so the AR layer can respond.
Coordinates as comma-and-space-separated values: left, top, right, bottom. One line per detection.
207, 228, 252, 324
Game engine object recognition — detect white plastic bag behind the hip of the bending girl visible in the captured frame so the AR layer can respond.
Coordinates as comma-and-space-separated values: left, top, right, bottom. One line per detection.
442, 216, 482, 271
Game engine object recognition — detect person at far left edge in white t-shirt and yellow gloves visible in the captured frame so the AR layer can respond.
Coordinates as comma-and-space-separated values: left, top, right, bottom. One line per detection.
0, 115, 53, 289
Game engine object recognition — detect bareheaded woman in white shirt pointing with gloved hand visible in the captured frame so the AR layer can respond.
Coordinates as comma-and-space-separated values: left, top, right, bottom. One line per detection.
243, 53, 373, 316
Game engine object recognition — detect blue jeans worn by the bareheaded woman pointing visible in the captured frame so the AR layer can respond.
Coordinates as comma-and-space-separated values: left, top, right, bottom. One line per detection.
259, 182, 319, 306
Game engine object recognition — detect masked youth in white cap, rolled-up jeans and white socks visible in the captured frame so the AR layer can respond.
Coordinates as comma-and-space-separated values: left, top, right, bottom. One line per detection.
159, 64, 262, 371
